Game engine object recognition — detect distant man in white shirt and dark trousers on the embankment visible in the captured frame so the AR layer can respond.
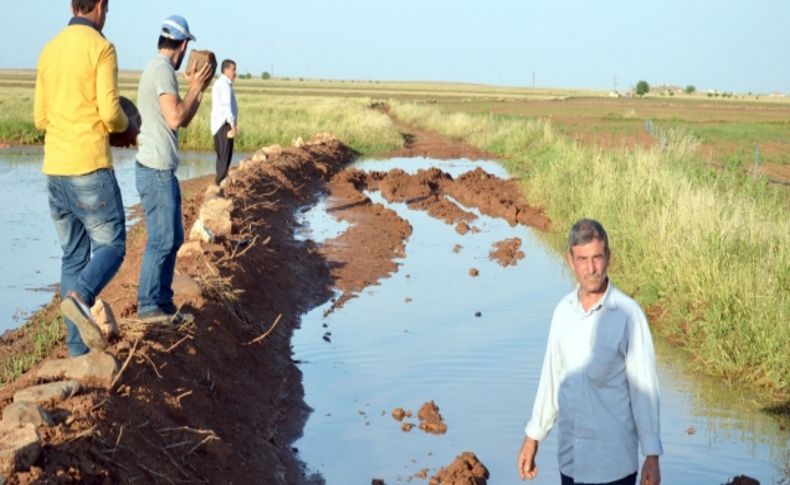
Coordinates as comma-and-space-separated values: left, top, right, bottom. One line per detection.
211, 59, 239, 185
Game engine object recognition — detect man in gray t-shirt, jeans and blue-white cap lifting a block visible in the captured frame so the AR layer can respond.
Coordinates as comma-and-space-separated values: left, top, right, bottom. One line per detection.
135, 15, 212, 323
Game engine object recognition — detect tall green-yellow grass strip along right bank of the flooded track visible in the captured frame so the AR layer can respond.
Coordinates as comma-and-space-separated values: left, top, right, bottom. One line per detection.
393, 102, 790, 393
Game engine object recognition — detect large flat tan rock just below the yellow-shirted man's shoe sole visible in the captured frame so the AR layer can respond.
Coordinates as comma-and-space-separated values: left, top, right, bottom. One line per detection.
35, 351, 118, 388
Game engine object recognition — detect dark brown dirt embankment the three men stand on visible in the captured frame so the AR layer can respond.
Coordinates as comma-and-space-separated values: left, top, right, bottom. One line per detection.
0, 136, 354, 483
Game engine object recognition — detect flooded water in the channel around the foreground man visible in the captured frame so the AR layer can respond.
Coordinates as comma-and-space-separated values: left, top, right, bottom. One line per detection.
293, 159, 790, 484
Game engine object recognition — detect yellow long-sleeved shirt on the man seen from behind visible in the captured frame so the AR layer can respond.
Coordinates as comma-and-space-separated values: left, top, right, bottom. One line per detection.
33, 21, 129, 175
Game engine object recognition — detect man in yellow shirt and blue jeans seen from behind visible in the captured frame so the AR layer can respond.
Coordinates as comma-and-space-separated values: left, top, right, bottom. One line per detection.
34, 0, 135, 357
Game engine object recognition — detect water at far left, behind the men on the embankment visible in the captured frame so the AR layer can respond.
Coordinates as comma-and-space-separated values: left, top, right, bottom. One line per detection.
0, 147, 242, 333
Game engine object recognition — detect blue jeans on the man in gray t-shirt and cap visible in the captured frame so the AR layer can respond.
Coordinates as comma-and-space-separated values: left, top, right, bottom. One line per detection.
135, 162, 184, 315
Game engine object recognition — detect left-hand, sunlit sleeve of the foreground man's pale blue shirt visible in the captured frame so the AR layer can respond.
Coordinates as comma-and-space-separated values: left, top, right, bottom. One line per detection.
525, 312, 562, 441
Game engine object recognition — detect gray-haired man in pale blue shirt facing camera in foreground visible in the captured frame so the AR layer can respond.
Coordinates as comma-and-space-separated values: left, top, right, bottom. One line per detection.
518, 219, 663, 485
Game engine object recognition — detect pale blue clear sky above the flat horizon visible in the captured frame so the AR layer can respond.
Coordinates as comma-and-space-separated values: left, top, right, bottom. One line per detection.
0, 0, 790, 93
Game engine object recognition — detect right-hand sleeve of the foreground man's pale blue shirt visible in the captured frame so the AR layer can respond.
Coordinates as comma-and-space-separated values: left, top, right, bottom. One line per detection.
625, 309, 664, 456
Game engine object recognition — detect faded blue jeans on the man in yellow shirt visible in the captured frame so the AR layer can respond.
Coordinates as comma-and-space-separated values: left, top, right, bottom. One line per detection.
47, 169, 126, 357
